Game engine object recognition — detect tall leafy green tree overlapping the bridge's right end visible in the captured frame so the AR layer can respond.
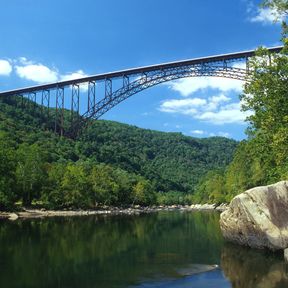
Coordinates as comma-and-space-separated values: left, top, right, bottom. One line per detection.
241, 43, 288, 170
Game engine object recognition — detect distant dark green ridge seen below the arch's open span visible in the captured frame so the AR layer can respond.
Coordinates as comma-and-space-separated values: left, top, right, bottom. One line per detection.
79, 121, 236, 193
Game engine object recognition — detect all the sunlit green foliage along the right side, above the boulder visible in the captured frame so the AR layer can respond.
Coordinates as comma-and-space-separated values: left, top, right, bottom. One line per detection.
194, 0, 288, 202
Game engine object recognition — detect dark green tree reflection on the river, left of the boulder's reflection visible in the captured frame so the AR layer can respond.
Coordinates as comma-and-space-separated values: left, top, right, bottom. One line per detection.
0, 212, 222, 287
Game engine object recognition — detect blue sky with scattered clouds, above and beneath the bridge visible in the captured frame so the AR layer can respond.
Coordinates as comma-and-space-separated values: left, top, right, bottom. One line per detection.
0, 0, 281, 140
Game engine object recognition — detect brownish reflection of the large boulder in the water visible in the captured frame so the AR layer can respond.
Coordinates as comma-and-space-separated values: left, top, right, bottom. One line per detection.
221, 244, 288, 288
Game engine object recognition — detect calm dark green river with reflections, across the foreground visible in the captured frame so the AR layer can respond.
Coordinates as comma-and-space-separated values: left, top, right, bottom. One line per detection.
0, 212, 288, 288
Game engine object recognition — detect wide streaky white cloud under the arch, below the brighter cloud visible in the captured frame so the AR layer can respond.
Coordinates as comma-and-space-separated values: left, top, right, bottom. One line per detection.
159, 94, 251, 125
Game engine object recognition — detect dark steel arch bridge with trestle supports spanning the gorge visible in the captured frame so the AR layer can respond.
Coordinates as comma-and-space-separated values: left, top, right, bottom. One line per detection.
0, 46, 283, 137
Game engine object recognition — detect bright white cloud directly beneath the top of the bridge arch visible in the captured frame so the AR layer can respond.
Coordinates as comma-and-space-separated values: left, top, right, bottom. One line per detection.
169, 77, 243, 97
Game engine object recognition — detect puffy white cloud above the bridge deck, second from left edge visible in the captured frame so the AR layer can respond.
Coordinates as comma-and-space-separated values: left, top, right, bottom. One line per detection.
15, 64, 58, 84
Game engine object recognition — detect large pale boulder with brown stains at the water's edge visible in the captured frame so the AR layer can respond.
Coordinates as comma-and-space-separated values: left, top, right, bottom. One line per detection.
220, 181, 288, 250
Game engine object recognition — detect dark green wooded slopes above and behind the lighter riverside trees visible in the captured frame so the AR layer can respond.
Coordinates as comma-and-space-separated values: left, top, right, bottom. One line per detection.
0, 99, 237, 206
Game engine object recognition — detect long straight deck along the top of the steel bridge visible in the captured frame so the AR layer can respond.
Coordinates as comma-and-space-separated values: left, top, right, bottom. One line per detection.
0, 46, 283, 96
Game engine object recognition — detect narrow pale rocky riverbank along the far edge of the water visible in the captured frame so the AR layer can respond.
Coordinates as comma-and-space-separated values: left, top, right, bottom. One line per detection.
0, 203, 228, 220
